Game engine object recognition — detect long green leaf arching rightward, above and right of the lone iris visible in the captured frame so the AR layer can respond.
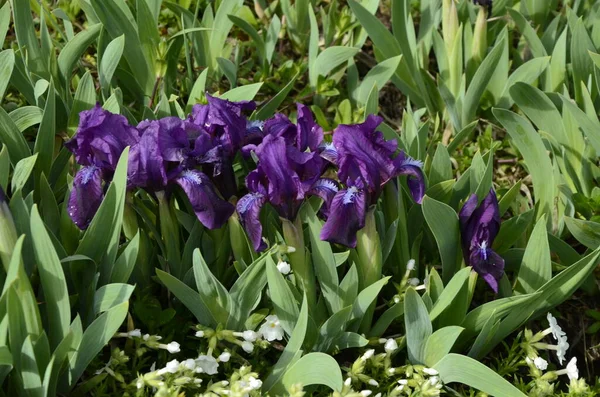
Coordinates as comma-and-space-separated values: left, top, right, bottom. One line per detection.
493, 109, 555, 227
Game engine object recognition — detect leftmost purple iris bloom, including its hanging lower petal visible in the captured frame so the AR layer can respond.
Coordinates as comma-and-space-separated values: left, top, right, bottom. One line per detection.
65, 104, 140, 229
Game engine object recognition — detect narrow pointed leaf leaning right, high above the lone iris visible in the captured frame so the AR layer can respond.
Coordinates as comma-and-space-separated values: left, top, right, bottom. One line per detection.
462, 40, 505, 125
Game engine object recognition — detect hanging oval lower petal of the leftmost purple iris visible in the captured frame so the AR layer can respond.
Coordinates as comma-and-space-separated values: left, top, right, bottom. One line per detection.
68, 165, 104, 230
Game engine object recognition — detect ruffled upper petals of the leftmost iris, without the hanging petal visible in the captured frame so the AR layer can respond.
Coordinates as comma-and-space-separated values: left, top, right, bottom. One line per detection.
65, 104, 139, 172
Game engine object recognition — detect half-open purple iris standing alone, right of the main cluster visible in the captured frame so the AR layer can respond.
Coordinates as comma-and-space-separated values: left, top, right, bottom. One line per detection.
459, 189, 504, 293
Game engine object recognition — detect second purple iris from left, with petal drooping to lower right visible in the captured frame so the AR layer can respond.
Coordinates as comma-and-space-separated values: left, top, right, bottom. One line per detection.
128, 117, 234, 229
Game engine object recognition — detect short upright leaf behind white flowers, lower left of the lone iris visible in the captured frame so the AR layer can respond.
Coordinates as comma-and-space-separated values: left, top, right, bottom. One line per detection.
404, 288, 433, 364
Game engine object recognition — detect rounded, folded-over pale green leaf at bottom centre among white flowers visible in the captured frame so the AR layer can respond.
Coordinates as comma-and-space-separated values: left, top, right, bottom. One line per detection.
282, 353, 344, 392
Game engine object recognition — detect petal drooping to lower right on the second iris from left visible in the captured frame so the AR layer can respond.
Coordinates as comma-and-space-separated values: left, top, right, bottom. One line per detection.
175, 170, 235, 229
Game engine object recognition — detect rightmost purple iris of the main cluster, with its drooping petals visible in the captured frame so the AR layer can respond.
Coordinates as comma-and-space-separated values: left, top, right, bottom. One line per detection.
321, 115, 425, 248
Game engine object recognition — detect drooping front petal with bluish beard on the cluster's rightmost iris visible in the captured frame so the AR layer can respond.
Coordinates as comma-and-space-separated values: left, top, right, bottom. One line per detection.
321, 186, 367, 248
